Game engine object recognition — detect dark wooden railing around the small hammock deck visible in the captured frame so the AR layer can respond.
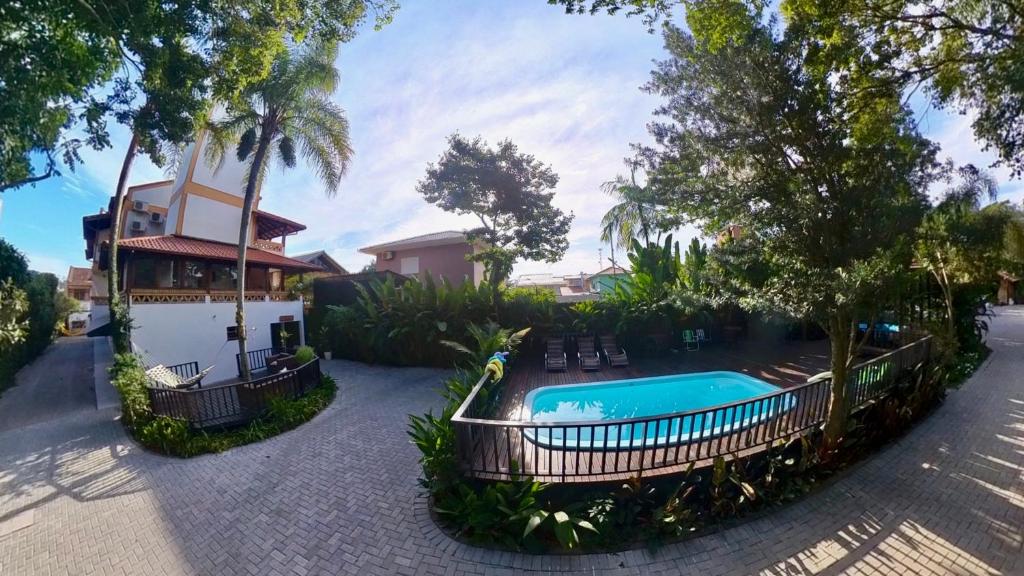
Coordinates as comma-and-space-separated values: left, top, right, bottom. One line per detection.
147, 359, 321, 429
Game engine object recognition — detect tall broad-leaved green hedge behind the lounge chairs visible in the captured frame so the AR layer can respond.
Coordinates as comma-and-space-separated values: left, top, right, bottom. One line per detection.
319, 277, 708, 367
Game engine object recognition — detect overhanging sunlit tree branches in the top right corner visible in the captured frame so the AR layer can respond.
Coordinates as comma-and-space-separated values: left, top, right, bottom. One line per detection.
781, 0, 1024, 175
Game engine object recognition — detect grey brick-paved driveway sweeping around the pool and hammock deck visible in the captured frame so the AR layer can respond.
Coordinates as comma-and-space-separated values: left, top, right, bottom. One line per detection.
0, 307, 1024, 576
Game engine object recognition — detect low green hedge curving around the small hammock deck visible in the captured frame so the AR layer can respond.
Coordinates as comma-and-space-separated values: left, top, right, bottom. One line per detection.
111, 355, 338, 458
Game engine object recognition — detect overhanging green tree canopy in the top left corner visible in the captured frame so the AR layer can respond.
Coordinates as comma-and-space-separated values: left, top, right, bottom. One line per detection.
0, 0, 397, 190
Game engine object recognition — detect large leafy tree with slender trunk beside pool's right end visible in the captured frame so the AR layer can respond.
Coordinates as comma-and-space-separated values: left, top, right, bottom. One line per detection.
647, 0, 935, 445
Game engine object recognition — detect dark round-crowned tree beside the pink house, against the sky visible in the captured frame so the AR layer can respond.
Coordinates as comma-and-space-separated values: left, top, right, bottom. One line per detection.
416, 133, 572, 286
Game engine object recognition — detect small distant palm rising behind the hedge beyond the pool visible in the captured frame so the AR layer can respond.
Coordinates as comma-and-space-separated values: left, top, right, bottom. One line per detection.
601, 161, 657, 253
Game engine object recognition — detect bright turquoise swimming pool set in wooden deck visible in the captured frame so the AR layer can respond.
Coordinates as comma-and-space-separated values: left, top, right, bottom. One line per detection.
523, 371, 797, 450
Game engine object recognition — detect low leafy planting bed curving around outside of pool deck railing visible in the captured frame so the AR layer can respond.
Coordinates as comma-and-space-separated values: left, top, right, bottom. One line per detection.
409, 336, 949, 552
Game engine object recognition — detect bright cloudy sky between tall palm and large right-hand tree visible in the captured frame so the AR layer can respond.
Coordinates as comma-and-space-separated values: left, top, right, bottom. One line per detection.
261, 1, 662, 274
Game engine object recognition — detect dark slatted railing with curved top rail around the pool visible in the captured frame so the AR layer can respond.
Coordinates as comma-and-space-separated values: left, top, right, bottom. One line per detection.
452, 337, 931, 482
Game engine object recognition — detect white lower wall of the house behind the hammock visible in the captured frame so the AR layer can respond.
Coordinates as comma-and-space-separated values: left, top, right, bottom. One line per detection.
131, 297, 303, 384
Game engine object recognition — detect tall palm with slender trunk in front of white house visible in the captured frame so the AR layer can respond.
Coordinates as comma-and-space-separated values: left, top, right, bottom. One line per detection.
208, 44, 352, 379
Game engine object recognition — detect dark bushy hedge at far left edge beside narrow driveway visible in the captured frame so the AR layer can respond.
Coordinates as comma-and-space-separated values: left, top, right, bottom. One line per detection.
0, 240, 62, 392
